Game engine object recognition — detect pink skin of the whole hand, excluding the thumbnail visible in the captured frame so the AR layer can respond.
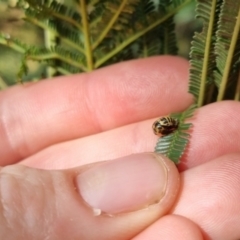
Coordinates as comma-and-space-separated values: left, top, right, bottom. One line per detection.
0, 56, 240, 240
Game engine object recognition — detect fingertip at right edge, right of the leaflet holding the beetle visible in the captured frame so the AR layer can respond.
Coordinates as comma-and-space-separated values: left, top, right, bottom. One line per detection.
179, 101, 240, 171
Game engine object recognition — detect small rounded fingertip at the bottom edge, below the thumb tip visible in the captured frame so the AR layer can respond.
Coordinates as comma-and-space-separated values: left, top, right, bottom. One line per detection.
132, 215, 203, 240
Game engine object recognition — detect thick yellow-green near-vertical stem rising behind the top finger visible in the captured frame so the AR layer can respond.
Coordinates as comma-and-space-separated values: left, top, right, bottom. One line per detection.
80, 0, 93, 72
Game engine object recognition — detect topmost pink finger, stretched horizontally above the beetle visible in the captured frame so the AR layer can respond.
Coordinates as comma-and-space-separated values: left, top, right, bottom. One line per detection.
0, 56, 192, 165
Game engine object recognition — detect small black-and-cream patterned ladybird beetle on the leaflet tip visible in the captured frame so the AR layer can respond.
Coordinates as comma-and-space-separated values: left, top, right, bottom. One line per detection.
152, 117, 179, 136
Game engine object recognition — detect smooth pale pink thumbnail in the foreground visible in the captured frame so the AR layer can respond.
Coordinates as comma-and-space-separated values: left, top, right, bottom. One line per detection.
76, 153, 168, 215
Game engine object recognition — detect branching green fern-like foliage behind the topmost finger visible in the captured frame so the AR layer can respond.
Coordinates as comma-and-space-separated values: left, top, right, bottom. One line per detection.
0, 0, 192, 78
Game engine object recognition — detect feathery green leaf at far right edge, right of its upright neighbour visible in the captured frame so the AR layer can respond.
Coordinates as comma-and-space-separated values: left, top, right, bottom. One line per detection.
214, 0, 240, 101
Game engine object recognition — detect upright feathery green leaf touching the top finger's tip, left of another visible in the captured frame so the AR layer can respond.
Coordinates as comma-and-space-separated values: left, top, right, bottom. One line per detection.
189, 0, 223, 106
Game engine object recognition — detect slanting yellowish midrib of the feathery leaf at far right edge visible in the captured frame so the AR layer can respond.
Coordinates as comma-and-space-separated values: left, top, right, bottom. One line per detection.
217, 9, 240, 101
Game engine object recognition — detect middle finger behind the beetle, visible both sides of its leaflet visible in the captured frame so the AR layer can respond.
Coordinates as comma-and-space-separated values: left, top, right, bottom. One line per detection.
22, 101, 240, 171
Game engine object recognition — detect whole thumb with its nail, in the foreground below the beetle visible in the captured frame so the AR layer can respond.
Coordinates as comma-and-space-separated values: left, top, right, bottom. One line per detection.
0, 153, 179, 240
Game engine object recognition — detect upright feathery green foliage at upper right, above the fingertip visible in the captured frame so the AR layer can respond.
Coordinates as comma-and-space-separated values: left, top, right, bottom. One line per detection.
189, 0, 240, 107
